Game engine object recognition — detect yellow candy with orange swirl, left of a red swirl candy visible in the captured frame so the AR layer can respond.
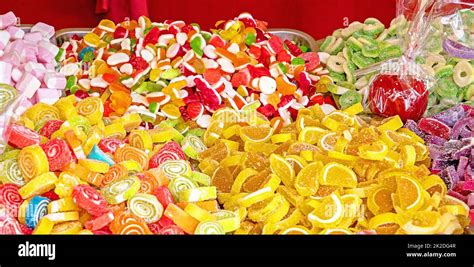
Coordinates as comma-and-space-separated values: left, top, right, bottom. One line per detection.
18, 145, 49, 181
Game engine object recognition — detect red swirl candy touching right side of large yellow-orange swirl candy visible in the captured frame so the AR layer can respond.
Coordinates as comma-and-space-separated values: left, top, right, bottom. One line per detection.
41, 139, 73, 172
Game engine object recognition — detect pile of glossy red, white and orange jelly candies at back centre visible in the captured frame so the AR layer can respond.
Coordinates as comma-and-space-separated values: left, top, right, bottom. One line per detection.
61, 13, 332, 128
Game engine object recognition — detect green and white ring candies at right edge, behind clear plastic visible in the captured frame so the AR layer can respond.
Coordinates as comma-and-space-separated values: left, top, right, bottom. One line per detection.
417, 9, 474, 115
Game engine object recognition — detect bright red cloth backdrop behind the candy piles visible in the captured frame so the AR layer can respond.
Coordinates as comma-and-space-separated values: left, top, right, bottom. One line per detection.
0, 0, 396, 39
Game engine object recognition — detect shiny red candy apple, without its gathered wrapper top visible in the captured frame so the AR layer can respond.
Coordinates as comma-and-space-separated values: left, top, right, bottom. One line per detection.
369, 74, 429, 121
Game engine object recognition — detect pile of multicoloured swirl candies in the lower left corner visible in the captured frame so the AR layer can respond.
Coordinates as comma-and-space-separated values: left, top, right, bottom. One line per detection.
0, 95, 244, 234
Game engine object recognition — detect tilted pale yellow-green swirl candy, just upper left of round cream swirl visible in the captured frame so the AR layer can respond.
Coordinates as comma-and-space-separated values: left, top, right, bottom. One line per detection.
102, 176, 141, 205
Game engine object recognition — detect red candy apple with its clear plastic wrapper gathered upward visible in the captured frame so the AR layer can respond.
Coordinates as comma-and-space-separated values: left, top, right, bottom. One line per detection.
362, 0, 435, 121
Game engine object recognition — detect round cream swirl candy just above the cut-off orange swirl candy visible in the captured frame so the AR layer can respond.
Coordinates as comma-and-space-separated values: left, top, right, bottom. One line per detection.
127, 193, 163, 223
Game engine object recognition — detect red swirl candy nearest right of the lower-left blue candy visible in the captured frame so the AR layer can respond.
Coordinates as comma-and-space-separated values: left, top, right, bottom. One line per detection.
72, 185, 107, 216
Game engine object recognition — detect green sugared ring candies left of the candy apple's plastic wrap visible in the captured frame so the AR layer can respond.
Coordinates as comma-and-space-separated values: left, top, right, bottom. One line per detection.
316, 16, 408, 109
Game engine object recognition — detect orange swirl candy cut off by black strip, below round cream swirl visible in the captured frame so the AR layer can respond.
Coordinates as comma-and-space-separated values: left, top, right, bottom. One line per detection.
110, 211, 152, 235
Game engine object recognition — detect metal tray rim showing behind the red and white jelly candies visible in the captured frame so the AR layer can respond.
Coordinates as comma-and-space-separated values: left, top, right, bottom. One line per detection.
55, 28, 319, 51
